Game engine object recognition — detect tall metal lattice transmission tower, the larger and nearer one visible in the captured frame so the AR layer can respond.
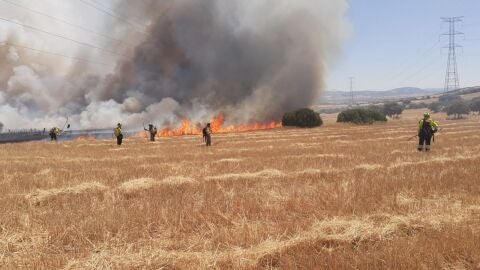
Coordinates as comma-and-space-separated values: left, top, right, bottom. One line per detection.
441, 17, 463, 94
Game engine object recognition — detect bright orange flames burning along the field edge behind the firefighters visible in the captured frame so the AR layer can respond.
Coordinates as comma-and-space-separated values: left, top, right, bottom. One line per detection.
157, 114, 282, 137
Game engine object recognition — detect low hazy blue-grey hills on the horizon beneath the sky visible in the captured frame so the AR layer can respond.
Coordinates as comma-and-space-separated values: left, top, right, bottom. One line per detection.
321, 87, 443, 103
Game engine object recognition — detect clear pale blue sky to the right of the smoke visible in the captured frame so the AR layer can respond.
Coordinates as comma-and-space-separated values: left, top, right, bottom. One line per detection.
327, 0, 480, 91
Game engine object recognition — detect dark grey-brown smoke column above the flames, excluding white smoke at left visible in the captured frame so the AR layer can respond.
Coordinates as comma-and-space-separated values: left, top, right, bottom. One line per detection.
105, 0, 345, 122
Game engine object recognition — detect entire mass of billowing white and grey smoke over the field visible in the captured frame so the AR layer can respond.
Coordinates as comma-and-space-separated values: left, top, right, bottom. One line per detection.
0, 0, 348, 131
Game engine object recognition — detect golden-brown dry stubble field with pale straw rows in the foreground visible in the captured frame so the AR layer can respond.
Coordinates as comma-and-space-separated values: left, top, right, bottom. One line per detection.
0, 108, 480, 269
